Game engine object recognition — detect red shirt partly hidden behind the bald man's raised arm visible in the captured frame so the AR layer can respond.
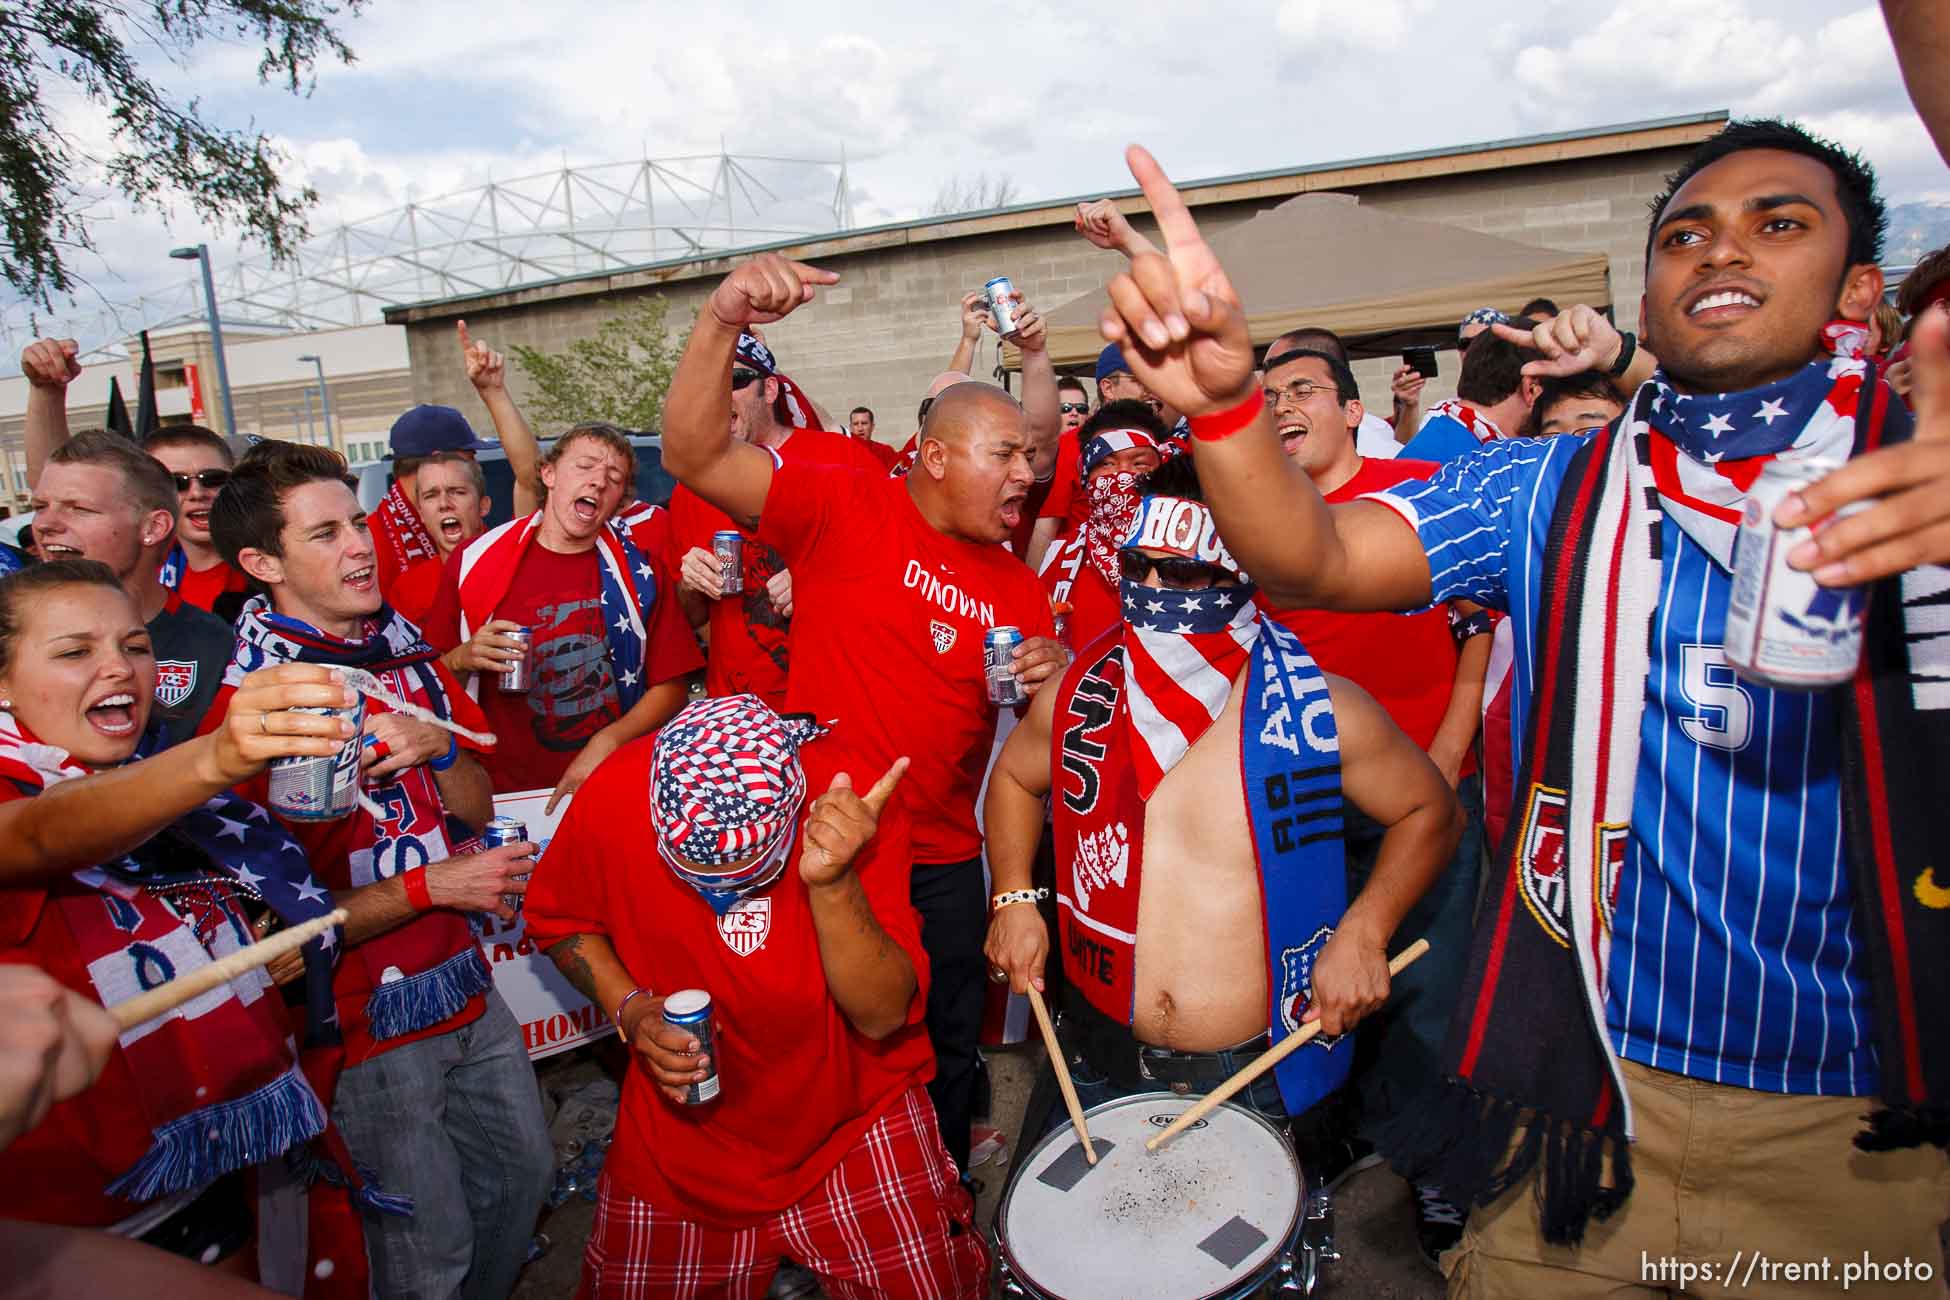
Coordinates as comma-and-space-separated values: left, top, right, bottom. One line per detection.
671, 429, 885, 709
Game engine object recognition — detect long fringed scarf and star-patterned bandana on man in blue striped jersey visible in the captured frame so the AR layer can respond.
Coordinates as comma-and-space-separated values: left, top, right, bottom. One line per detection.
1385, 359, 1950, 1243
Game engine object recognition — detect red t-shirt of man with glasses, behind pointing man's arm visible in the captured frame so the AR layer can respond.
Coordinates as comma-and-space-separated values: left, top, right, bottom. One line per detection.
1262, 456, 1474, 776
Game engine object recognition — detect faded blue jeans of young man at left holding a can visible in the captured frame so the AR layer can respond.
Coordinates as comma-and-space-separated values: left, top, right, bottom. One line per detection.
332, 990, 556, 1300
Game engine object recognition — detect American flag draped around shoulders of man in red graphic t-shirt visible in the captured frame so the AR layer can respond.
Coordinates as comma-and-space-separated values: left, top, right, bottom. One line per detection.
460, 511, 657, 713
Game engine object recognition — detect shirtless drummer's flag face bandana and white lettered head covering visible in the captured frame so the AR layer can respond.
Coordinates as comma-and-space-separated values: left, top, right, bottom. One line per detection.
1117, 497, 1260, 799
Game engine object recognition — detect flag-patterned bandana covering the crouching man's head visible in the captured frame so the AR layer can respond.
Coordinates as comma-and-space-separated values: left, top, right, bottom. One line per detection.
649, 696, 827, 916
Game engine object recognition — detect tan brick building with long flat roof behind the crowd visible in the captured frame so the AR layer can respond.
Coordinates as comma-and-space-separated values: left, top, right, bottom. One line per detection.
386, 113, 1726, 440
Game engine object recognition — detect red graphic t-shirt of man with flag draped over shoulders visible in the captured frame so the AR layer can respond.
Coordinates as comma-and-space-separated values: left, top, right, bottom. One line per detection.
421, 540, 702, 791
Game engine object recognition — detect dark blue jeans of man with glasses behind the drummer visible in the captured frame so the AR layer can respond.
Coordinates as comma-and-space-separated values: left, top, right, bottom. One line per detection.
1346, 776, 1482, 1136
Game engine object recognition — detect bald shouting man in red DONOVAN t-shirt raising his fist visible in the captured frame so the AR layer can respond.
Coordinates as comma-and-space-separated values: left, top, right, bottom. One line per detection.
663, 253, 1065, 1169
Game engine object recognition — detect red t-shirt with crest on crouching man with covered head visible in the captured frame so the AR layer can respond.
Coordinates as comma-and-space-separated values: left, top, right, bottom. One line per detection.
525, 727, 934, 1230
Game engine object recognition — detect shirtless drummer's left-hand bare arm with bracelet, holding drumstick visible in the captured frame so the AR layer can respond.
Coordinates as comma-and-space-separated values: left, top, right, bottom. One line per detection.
983, 690, 1057, 992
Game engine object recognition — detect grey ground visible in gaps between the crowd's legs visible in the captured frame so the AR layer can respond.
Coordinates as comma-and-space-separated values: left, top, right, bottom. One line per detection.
515, 1047, 1443, 1300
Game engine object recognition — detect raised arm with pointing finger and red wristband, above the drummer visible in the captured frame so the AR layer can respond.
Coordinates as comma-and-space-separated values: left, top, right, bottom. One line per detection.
1100, 144, 1429, 610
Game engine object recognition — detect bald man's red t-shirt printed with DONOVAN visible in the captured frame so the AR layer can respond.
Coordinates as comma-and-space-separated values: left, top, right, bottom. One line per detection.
759, 464, 1053, 865
